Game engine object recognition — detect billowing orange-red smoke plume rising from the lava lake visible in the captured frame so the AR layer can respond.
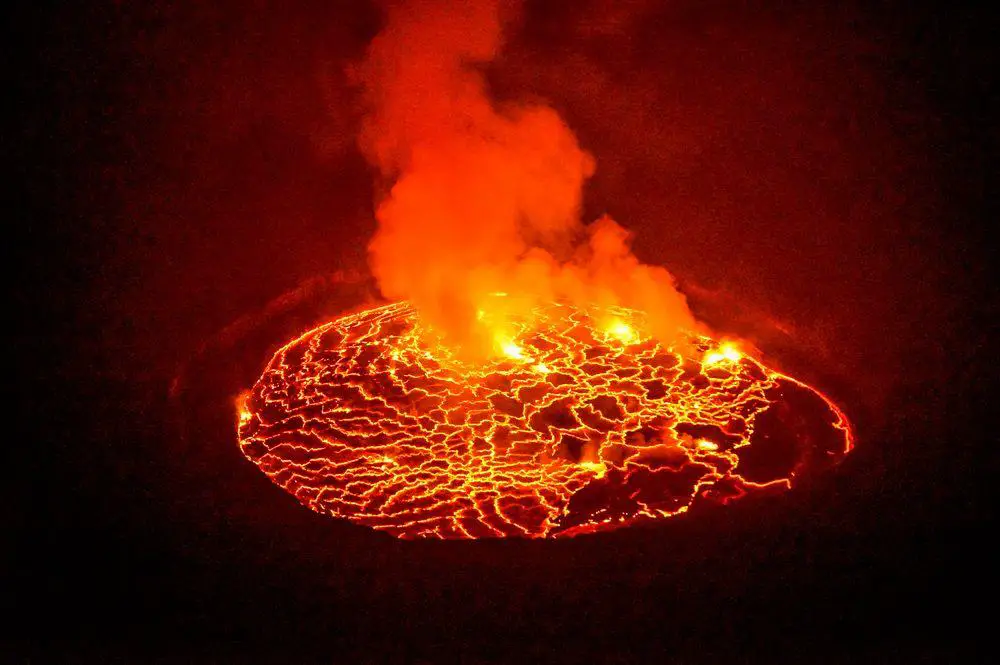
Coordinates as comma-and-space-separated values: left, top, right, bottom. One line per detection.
353, 0, 699, 355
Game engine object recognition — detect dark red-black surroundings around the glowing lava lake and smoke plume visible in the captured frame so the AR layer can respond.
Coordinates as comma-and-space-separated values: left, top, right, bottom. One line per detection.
0, 0, 1000, 663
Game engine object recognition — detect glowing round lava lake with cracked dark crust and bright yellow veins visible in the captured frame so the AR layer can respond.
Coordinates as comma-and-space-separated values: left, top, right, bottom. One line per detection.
239, 303, 852, 538
